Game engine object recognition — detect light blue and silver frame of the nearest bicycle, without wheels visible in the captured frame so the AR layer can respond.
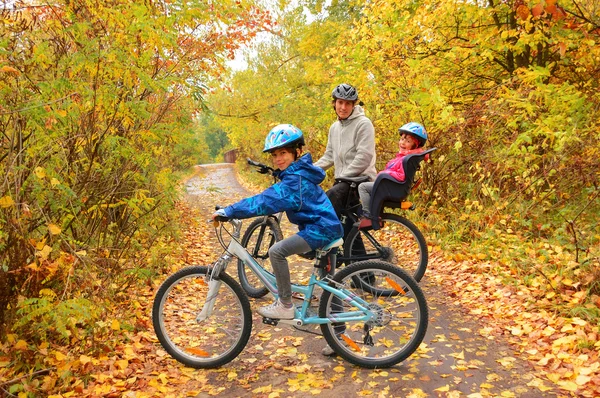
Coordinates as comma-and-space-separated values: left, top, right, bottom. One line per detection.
204, 219, 374, 326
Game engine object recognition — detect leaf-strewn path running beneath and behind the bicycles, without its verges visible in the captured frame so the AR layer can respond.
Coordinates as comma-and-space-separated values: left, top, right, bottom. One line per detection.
159, 164, 561, 398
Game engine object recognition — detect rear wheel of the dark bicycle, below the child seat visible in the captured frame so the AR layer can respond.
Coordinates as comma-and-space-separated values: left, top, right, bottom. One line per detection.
344, 213, 429, 282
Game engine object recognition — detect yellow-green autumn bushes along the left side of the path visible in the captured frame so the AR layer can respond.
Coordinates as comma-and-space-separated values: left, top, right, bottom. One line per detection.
0, 0, 268, 393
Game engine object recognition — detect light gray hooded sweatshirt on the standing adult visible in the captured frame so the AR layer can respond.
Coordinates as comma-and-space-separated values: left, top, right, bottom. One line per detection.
314, 105, 377, 181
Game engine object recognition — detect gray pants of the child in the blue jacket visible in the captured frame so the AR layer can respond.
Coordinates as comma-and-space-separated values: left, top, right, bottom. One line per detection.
269, 234, 312, 304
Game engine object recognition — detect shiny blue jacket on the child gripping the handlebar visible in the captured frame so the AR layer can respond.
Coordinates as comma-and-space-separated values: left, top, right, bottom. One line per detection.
225, 153, 343, 250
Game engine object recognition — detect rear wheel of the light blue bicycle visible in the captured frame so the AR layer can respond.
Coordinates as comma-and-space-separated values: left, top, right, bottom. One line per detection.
319, 260, 429, 368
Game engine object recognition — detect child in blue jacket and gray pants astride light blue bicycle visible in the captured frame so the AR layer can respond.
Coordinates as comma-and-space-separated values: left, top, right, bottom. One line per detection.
213, 124, 343, 319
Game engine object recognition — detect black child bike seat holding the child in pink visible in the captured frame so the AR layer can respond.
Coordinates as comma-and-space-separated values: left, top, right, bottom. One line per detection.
370, 148, 437, 230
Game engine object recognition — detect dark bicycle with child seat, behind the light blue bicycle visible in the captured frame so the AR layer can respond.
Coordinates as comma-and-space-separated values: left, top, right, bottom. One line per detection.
238, 148, 436, 298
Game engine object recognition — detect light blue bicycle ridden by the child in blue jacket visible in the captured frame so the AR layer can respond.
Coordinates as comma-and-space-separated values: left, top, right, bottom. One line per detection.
152, 217, 429, 368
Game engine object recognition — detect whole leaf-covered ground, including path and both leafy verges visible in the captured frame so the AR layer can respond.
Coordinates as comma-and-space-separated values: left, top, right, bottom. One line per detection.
9, 165, 600, 398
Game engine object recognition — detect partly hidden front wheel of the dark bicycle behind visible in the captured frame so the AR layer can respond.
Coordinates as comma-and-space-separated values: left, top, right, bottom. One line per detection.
238, 217, 283, 298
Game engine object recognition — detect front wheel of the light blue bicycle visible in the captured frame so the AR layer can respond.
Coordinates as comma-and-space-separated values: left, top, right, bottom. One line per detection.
152, 266, 252, 368
